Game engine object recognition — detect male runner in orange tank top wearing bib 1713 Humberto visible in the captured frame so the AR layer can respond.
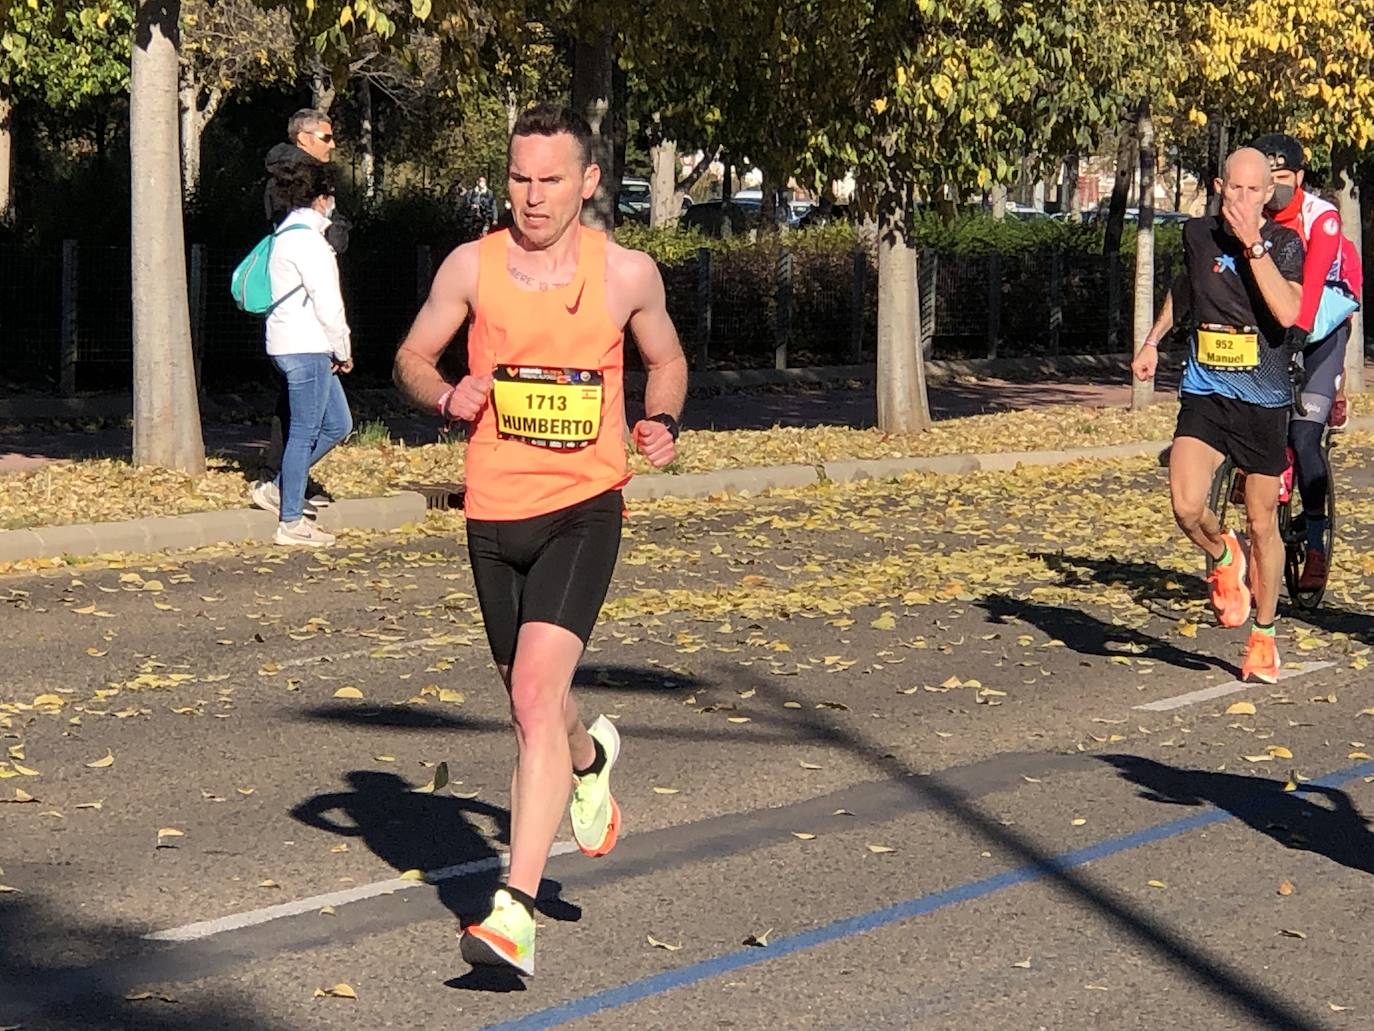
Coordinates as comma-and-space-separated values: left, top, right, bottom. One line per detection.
394, 104, 687, 973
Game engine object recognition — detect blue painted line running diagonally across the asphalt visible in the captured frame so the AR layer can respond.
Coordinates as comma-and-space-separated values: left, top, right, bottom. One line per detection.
482, 762, 1374, 1031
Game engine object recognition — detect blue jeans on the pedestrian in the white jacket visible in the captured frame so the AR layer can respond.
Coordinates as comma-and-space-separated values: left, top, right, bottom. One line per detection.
272, 355, 353, 522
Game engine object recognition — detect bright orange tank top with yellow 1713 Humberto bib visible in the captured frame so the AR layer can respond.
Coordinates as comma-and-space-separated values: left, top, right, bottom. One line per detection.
464, 227, 629, 520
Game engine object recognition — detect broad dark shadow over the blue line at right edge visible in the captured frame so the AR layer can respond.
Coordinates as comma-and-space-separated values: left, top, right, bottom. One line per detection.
1098, 755, 1374, 873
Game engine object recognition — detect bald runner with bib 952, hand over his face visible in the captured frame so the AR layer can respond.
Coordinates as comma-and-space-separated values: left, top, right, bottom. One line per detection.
1132, 147, 1303, 683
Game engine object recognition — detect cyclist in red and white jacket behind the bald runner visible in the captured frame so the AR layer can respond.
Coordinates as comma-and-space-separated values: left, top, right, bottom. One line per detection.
1250, 133, 1364, 591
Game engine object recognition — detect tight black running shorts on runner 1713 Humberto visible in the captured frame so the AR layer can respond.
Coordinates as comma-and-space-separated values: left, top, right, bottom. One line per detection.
467, 491, 624, 665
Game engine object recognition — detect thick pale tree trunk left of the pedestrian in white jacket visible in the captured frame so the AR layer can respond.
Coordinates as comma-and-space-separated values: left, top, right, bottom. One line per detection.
129, 0, 205, 476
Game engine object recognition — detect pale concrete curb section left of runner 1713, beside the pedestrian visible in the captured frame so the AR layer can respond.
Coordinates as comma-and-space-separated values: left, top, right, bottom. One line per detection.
0, 491, 426, 562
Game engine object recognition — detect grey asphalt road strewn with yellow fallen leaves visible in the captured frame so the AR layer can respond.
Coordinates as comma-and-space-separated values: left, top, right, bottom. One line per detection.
0, 444, 1374, 1031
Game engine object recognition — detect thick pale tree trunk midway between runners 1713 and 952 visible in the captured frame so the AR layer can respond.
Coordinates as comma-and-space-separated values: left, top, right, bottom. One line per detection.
878, 184, 930, 433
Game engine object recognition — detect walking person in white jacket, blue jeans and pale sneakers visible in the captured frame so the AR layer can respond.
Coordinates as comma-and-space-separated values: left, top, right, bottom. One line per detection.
253, 165, 353, 547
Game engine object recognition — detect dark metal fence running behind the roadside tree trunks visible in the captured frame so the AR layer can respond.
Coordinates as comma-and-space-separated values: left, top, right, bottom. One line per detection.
0, 241, 1173, 395
